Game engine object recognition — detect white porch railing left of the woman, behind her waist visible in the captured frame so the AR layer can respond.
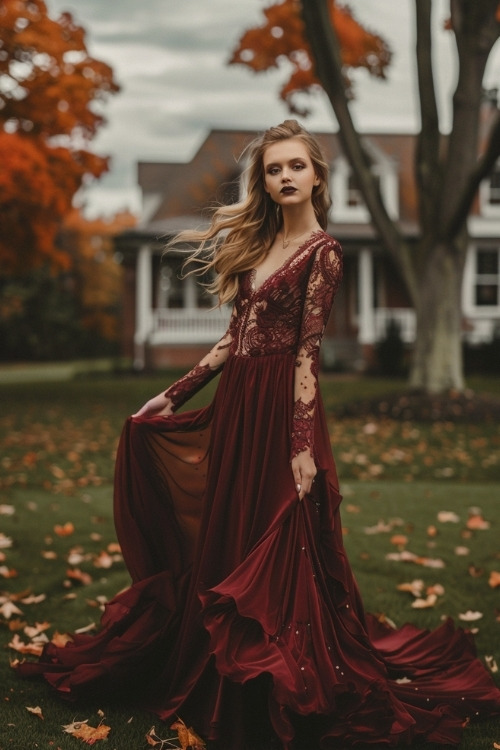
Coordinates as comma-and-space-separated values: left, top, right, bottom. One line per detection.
149, 307, 231, 345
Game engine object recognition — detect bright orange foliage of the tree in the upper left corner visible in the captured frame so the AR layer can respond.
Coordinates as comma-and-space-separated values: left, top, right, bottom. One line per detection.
0, 0, 118, 273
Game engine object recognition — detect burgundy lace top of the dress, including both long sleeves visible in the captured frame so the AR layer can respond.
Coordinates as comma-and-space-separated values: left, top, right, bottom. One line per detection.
166, 231, 342, 458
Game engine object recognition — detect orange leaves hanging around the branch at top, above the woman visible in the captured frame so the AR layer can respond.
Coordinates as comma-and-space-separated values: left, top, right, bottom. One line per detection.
229, 0, 391, 115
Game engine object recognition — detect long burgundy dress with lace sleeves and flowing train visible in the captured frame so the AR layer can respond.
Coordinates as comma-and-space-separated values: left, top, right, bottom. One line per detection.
21, 232, 500, 750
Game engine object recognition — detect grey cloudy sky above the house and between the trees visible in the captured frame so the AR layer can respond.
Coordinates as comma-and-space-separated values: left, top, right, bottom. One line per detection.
46, 0, 500, 216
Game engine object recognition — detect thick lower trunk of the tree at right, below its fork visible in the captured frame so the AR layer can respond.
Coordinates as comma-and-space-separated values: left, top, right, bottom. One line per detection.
410, 238, 466, 393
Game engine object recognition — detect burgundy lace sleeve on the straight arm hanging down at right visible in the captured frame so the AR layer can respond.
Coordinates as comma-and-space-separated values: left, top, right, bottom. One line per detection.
290, 240, 342, 459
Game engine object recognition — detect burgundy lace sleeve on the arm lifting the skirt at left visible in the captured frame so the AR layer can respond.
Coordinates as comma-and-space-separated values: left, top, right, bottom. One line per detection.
165, 308, 236, 411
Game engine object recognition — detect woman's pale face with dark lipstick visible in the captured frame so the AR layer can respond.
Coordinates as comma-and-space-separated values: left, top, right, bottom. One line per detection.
262, 138, 320, 208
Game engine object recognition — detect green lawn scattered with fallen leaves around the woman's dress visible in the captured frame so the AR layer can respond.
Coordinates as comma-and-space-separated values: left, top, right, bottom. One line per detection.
0, 376, 500, 750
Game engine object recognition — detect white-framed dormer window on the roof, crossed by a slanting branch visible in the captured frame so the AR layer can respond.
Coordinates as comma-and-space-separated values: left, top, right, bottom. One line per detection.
331, 143, 399, 224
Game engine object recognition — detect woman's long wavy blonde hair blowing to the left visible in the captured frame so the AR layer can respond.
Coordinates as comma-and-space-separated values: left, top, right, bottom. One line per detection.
168, 120, 331, 305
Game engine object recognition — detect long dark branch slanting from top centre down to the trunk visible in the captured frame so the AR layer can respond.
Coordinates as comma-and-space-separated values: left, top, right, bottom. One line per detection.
301, 0, 417, 301
